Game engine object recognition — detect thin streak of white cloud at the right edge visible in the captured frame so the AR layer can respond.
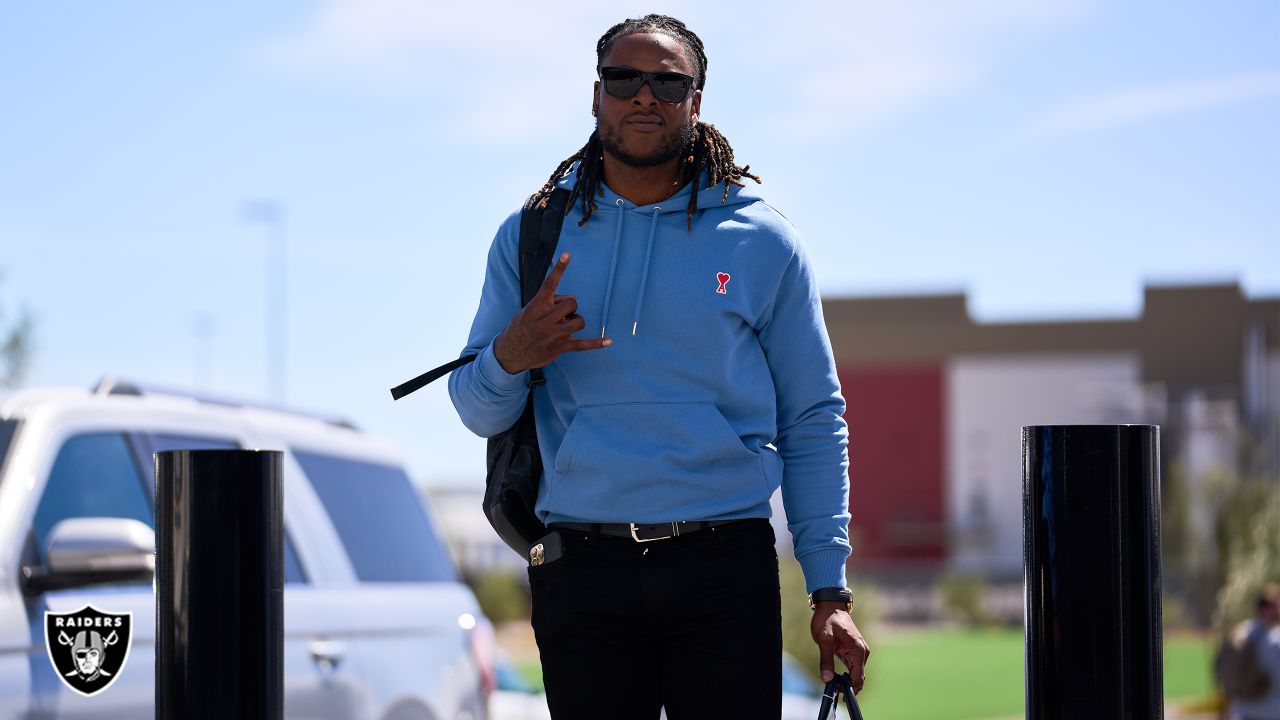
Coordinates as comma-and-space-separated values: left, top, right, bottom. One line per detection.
1024, 72, 1280, 138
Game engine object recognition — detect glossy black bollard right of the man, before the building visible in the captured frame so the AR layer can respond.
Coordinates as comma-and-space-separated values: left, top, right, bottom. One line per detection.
1023, 425, 1164, 720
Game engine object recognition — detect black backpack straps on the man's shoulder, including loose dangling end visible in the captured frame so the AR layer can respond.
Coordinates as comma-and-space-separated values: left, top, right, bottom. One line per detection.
392, 187, 568, 400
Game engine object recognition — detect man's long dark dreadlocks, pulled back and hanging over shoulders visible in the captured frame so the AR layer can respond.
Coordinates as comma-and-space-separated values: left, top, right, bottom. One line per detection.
534, 14, 760, 231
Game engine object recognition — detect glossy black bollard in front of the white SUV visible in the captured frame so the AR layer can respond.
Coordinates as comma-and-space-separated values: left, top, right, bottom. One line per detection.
155, 450, 284, 720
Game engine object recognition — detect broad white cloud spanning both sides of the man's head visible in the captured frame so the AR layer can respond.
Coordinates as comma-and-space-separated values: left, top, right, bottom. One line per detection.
260, 0, 1094, 140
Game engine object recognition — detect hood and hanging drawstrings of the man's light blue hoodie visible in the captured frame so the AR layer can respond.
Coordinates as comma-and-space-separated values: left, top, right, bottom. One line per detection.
556, 165, 763, 337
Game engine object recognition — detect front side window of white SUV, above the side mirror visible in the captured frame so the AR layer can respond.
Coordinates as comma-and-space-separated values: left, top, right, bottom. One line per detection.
35, 433, 155, 562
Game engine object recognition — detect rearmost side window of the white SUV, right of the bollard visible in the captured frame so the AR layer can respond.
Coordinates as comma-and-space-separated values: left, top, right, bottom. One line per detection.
293, 450, 456, 583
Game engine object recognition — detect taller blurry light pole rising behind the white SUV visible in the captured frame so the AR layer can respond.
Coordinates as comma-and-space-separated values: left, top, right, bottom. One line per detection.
244, 200, 289, 405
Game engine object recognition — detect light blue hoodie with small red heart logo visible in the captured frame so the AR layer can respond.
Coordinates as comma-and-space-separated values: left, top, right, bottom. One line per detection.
449, 166, 849, 592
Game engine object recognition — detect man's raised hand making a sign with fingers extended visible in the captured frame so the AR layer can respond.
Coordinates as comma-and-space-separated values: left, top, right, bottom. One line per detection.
493, 252, 613, 375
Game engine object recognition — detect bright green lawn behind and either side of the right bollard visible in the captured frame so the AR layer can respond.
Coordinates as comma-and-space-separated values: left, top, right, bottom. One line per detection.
859, 628, 1211, 720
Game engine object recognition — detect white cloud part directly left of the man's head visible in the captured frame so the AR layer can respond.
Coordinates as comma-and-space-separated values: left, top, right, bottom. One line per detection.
257, 0, 614, 140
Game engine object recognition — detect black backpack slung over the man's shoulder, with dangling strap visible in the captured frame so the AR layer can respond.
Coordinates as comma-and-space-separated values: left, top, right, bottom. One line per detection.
392, 188, 568, 560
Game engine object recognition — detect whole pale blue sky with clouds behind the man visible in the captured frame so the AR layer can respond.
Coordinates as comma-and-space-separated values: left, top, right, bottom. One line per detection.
0, 0, 1280, 483
